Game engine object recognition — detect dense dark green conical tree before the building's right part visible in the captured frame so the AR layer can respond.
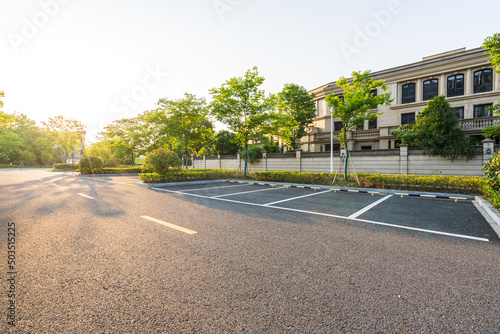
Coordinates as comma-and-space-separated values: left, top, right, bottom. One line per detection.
415, 95, 477, 161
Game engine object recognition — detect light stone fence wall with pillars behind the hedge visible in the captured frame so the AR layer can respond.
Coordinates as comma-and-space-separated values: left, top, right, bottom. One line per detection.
191, 139, 495, 176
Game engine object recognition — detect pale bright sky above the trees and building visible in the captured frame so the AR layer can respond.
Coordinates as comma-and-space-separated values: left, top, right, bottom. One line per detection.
0, 0, 500, 142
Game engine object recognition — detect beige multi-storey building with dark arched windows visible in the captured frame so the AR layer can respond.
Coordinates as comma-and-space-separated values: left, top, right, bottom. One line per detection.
300, 48, 500, 152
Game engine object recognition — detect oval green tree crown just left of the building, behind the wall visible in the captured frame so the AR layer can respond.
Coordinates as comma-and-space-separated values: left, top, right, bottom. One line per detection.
275, 83, 316, 149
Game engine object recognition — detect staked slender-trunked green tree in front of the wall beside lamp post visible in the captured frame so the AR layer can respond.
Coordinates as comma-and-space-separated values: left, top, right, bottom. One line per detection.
326, 70, 393, 179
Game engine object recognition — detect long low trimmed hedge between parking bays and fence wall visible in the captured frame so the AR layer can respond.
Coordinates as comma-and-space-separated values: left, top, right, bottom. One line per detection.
139, 169, 487, 195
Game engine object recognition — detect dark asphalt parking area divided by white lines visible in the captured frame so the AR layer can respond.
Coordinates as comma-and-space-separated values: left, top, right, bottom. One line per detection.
153, 182, 498, 241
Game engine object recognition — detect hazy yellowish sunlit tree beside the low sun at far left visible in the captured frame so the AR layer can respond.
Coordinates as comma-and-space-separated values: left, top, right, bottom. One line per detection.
42, 115, 86, 160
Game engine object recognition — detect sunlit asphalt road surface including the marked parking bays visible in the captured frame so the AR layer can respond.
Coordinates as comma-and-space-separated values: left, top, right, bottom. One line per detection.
0, 169, 500, 333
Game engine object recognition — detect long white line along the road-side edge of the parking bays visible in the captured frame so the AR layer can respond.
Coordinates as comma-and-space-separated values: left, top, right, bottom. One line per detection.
150, 188, 489, 242
